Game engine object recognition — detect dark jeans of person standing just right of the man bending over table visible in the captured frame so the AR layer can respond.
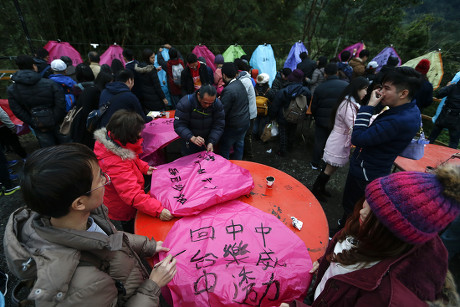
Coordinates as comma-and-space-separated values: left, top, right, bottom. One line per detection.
220, 123, 249, 160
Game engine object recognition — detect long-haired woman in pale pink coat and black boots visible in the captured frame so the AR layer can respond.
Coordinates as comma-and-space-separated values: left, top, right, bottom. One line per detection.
312, 77, 369, 201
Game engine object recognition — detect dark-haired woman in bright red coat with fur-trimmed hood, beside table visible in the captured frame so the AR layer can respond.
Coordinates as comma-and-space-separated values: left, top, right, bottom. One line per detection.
94, 110, 173, 233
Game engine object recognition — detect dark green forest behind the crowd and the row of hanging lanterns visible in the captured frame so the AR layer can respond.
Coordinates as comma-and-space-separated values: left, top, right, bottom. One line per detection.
0, 0, 460, 145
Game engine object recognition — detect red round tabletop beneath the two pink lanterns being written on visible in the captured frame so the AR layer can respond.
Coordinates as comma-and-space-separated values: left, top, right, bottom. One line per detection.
134, 160, 329, 262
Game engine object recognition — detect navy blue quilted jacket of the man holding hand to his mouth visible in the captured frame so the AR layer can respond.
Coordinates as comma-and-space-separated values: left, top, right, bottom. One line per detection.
350, 100, 421, 182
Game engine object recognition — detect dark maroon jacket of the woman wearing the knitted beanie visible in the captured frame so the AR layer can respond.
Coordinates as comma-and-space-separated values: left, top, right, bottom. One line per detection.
291, 236, 448, 307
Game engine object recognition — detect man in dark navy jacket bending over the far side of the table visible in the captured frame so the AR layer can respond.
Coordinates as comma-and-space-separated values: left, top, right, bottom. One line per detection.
174, 84, 225, 156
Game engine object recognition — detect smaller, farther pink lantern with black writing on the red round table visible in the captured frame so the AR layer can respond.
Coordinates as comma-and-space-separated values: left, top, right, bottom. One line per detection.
150, 151, 254, 216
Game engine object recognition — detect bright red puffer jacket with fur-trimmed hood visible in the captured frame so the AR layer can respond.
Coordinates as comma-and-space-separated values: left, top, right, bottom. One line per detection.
94, 128, 163, 221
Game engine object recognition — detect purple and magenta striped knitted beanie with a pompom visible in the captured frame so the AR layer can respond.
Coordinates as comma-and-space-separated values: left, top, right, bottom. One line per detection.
366, 164, 460, 244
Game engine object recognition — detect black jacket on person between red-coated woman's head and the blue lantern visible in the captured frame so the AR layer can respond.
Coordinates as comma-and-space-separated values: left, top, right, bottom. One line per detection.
139, 63, 165, 111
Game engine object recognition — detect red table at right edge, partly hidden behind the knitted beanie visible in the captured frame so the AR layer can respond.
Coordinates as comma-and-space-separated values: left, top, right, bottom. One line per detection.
394, 144, 460, 172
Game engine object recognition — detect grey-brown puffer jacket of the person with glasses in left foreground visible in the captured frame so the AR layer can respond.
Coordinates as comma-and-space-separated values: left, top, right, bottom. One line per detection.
3, 205, 160, 307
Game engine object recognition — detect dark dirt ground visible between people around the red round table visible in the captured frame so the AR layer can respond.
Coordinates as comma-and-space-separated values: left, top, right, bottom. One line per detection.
0, 124, 460, 306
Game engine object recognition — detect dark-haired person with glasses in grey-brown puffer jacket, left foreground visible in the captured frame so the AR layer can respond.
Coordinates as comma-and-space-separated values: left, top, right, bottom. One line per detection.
4, 143, 176, 307
